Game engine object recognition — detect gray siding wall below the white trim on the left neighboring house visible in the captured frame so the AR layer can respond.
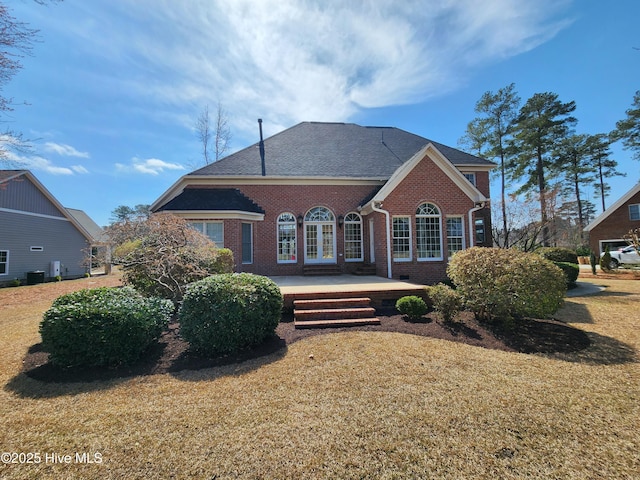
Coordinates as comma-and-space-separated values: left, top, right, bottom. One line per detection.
0, 211, 89, 282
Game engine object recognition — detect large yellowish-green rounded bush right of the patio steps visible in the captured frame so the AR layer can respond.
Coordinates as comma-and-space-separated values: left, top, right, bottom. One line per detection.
447, 247, 567, 320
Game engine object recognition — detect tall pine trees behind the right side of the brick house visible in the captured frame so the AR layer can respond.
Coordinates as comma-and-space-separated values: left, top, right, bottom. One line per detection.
460, 83, 640, 250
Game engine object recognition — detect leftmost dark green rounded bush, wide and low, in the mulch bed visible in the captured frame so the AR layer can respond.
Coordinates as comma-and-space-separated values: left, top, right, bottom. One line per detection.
40, 287, 174, 367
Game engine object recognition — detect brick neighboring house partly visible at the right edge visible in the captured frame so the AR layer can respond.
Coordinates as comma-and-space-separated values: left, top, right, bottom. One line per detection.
585, 183, 640, 254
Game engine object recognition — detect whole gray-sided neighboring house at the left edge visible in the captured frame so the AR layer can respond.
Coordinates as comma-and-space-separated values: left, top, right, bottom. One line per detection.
0, 170, 102, 284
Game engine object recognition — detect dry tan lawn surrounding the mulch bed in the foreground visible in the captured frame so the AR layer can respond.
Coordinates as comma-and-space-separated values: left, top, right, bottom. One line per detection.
0, 279, 640, 479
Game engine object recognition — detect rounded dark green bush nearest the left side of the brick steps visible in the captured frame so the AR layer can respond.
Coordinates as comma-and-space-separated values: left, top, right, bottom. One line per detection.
180, 273, 283, 355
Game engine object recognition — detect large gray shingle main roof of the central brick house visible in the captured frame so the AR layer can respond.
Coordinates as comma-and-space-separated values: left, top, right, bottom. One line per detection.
189, 122, 493, 179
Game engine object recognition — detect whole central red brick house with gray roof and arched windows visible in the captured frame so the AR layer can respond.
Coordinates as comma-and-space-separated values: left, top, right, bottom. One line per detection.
151, 122, 495, 283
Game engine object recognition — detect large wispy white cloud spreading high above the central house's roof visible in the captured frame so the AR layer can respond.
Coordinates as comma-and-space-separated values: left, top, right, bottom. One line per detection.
56, 0, 571, 139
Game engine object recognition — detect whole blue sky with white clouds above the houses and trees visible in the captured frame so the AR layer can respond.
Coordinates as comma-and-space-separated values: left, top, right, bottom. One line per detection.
4, 0, 640, 225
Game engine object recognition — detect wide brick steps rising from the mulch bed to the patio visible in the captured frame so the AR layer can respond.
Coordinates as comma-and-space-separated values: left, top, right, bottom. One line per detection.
293, 297, 380, 328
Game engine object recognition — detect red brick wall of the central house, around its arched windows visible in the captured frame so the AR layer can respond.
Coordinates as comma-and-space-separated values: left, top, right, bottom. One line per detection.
179, 158, 490, 283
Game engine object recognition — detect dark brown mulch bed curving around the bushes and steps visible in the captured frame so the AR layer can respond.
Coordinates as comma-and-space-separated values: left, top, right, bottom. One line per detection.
23, 308, 590, 382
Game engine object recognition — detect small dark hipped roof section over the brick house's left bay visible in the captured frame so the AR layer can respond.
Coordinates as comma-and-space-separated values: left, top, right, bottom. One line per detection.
158, 187, 264, 214
